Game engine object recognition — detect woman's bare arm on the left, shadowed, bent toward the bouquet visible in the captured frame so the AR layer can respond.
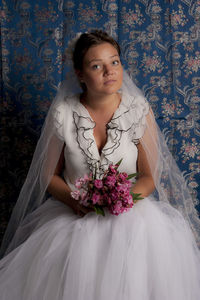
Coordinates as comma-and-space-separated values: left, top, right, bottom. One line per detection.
47, 146, 93, 215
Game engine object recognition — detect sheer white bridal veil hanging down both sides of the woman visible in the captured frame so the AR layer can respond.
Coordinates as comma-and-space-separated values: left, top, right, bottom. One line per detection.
0, 71, 200, 257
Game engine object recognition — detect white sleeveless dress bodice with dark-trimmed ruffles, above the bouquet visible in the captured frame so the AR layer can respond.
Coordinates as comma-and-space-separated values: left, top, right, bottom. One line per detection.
55, 94, 149, 189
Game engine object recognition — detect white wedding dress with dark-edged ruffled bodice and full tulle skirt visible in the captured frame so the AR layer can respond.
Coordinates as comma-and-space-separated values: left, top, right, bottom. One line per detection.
0, 95, 200, 300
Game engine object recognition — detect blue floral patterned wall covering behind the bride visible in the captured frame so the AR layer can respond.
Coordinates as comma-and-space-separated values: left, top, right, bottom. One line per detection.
0, 0, 200, 244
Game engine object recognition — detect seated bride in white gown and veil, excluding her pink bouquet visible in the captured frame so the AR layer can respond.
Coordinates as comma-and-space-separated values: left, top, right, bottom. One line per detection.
0, 31, 200, 300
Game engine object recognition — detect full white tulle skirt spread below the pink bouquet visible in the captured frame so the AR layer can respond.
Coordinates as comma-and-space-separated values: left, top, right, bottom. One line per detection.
0, 197, 200, 300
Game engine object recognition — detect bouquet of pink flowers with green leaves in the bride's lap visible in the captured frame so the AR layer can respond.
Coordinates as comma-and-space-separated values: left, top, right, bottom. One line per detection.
71, 159, 143, 216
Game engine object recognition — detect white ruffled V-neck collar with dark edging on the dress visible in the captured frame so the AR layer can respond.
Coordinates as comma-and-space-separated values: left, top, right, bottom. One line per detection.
70, 94, 148, 175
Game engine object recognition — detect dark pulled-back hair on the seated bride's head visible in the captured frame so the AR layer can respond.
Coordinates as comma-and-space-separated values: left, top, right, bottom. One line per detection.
72, 30, 120, 70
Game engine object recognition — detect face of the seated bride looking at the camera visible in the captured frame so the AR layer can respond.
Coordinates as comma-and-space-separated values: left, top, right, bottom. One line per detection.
78, 43, 123, 96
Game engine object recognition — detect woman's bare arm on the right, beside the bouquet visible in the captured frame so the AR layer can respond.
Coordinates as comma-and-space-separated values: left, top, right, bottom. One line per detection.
132, 143, 155, 198
